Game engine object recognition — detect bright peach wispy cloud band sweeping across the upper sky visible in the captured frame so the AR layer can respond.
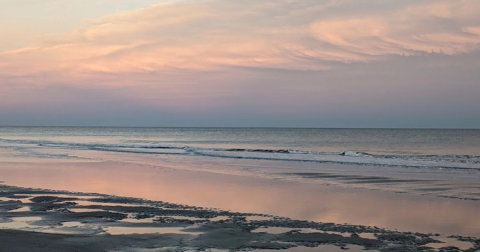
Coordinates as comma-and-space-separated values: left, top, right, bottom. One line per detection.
0, 0, 480, 74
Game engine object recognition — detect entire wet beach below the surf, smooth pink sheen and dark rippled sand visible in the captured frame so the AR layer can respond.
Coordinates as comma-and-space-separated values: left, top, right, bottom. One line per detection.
0, 151, 480, 252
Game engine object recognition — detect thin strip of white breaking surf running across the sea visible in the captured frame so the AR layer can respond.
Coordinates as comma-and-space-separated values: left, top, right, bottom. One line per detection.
0, 138, 480, 169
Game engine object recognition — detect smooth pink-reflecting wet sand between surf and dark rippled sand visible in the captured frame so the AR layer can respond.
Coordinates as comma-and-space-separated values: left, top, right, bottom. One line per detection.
1, 154, 480, 236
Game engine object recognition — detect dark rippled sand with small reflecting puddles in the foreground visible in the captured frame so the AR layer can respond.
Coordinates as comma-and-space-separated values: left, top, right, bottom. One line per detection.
0, 185, 480, 252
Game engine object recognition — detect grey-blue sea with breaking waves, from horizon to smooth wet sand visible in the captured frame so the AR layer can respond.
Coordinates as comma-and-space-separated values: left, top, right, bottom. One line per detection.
0, 127, 480, 169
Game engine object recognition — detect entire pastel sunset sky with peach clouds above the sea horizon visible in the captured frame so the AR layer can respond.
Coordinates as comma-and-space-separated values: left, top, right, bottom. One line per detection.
0, 0, 480, 128
